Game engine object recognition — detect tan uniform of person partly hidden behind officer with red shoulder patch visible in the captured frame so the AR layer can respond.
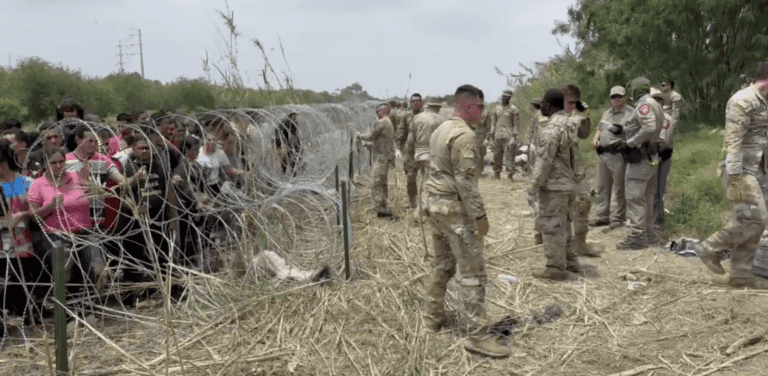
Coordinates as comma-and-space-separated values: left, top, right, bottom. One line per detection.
653, 91, 683, 224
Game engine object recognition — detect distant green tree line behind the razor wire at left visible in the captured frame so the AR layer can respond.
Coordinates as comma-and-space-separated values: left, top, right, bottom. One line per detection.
0, 57, 373, 123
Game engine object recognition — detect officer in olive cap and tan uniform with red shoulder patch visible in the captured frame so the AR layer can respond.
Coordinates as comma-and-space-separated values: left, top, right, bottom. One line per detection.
616, 77, 664, 250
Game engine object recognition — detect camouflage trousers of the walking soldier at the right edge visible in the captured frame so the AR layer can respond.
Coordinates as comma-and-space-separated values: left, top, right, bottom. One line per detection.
705, 174, 768, 279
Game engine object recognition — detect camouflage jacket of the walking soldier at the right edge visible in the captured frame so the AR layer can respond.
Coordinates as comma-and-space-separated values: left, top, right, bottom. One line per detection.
723, 84, 768, 175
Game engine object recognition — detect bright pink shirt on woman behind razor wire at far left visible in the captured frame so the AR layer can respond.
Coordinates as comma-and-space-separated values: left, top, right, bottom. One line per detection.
27, 172, 91, 233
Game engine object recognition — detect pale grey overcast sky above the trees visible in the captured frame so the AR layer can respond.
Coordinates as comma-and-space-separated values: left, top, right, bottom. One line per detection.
0, 0, 575, 100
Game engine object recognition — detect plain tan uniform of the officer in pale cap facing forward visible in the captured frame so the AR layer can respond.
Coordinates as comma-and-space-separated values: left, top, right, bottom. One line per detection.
595, 105, 637, 226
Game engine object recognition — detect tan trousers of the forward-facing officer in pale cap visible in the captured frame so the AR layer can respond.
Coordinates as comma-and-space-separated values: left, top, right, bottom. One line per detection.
595, 153, 627, 223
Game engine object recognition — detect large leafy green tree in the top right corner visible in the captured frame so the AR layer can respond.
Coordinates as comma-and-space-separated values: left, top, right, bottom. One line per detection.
576, 0, 768, 123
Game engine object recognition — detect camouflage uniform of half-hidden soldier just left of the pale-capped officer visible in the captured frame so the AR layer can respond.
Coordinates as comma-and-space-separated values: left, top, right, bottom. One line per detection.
565, 102, 596, 256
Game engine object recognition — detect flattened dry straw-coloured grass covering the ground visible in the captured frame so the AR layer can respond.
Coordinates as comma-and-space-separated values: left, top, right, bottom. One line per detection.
0, 163, 768, 375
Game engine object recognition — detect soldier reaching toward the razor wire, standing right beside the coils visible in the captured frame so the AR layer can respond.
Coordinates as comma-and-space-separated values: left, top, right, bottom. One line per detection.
357, 103, 395, 217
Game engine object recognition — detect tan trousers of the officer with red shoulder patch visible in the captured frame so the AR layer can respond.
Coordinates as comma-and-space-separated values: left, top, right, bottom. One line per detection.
624, 160, 656, 244
